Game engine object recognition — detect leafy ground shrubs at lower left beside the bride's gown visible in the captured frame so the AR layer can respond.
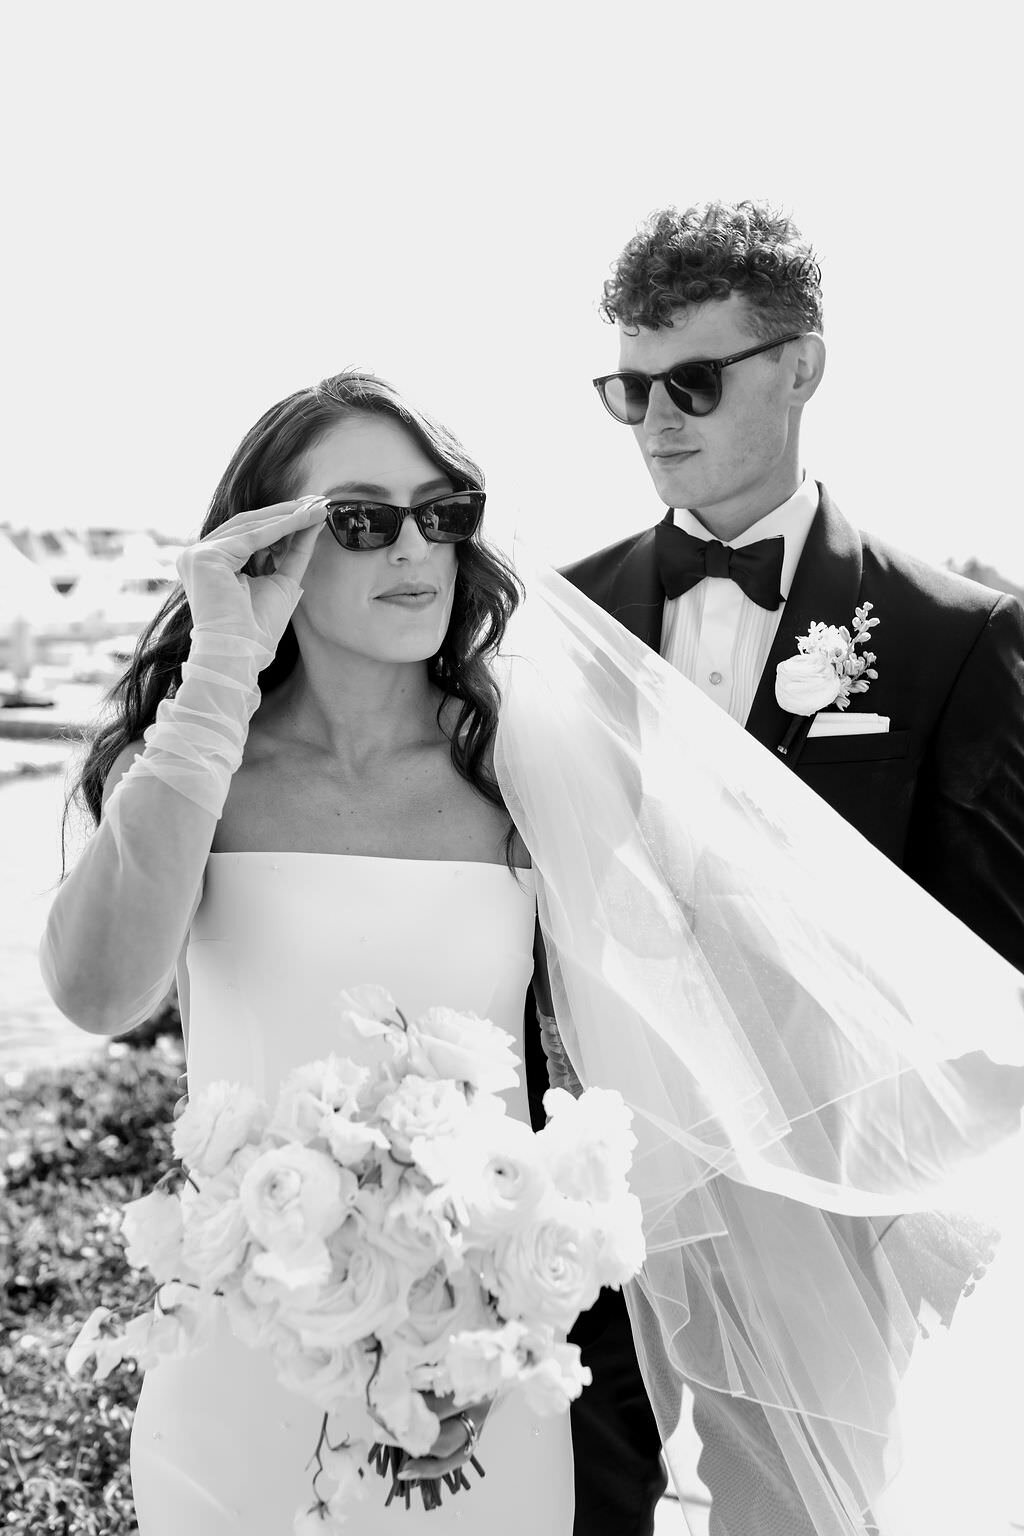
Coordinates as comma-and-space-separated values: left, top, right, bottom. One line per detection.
0, 1038, 183, 1536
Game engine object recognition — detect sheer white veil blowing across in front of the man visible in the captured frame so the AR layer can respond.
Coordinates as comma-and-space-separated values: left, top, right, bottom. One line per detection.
494, 562, 1024, 1536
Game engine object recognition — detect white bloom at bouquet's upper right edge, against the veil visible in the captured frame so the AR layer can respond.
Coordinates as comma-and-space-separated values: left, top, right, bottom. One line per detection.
536, 1087, 637, 1200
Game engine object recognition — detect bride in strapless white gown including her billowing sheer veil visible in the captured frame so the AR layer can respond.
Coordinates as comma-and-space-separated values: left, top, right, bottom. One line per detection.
43, 373, 1024, 1536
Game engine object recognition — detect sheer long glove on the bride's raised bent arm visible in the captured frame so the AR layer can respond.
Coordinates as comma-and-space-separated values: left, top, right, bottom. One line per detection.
40, 498, 324, 1034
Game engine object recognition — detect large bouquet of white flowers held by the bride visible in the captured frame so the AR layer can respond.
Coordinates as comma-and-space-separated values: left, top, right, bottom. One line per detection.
68, 986, 643, 1536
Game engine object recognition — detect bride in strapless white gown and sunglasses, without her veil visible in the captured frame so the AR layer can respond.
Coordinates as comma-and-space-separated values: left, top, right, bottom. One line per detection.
43, 373, 573, 1536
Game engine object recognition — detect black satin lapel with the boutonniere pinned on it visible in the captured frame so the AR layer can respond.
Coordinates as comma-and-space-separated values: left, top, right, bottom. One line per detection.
746, 484, 863, 751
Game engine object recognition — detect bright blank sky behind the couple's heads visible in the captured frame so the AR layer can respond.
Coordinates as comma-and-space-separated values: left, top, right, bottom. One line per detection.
0, 0, 1024, 579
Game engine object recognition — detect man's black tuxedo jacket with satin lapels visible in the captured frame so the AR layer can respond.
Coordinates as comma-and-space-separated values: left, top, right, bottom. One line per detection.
562, 485, 1024, 971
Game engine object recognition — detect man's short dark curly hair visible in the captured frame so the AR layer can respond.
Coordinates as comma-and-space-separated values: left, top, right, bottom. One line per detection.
600, 201, 823, 341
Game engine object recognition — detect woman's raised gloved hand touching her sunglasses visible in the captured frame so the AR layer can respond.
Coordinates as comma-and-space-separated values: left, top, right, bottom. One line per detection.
178, 496, 327, 650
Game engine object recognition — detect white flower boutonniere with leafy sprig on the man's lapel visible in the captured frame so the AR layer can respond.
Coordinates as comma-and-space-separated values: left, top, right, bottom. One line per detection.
775, 602, 881, 757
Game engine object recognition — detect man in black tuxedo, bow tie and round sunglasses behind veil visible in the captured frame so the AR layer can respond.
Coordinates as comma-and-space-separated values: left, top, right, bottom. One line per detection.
552, 203, 1024, 1536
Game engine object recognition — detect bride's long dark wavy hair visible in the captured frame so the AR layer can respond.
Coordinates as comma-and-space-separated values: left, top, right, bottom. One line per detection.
68, 369, 522, 865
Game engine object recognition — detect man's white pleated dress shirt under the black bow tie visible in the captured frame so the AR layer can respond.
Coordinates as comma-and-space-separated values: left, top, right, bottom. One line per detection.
662, 476, 818, 725
